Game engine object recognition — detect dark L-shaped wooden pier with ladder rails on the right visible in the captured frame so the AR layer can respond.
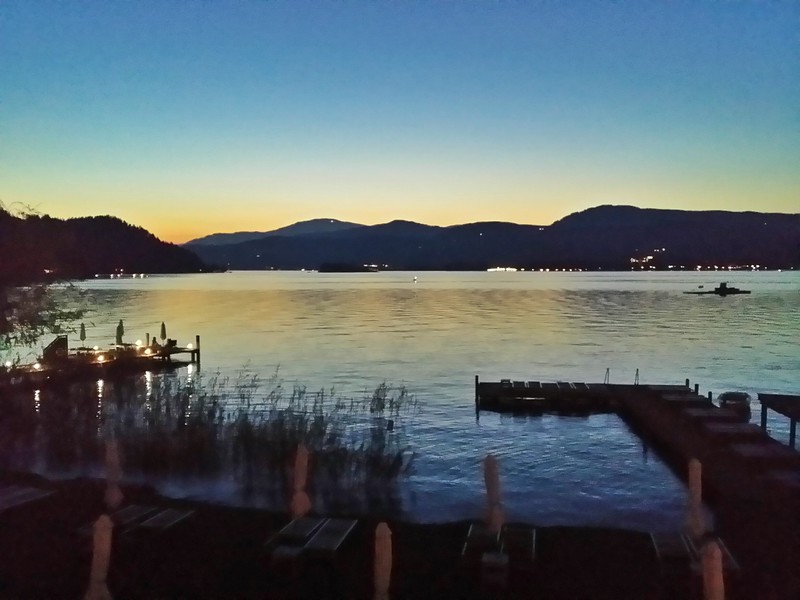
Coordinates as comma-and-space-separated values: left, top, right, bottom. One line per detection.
475, 375, 800, 598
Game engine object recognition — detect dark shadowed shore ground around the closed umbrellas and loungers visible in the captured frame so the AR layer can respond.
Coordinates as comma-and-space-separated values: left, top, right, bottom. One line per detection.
0, 473, 764, 600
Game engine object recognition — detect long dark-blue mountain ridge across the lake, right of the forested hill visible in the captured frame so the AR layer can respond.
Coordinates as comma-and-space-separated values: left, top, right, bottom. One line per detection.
188, 205, 800, 270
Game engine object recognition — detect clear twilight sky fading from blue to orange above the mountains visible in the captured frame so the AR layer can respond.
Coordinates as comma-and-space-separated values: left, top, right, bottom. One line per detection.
0, 0, 800, 243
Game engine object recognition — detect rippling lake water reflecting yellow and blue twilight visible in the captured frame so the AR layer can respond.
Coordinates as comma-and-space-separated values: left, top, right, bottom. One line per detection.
7, 271, 800, 530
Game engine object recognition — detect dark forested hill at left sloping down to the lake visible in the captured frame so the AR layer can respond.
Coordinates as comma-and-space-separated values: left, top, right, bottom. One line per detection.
0, 208, 209, 283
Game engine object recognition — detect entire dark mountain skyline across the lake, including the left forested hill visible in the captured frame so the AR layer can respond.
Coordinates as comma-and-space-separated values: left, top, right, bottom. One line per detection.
0, 206, 800, 286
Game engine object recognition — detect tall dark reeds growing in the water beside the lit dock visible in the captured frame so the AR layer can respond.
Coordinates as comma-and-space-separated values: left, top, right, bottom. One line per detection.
0, 369, 419, 511
